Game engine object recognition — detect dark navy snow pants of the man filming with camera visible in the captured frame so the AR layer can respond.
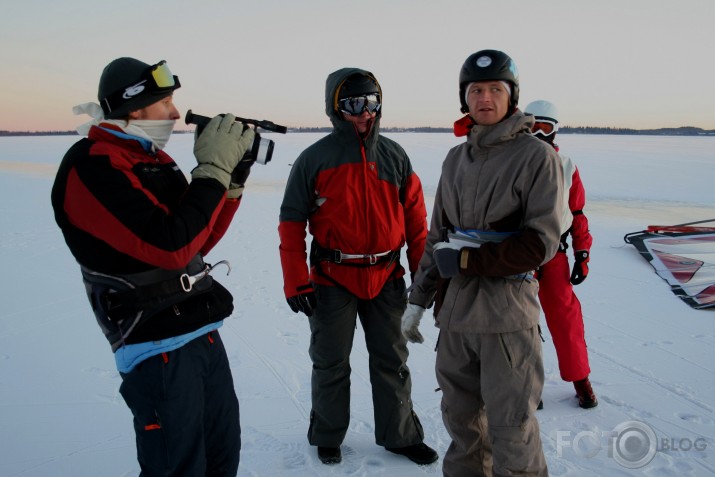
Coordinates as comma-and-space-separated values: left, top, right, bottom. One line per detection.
120, 331, 241, 477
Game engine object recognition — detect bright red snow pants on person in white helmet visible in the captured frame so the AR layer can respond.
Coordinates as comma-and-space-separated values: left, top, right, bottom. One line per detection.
539, 251, 591, 381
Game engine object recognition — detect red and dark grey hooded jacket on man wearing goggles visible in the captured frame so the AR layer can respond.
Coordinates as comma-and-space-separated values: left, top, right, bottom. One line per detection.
278, 68, 427, 299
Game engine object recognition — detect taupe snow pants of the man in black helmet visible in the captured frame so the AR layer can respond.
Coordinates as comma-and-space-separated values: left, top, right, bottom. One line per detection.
436, 326, 548, 477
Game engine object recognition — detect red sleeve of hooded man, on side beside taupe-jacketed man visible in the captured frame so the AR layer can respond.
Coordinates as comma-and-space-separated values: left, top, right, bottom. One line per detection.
403, 173, 427, 274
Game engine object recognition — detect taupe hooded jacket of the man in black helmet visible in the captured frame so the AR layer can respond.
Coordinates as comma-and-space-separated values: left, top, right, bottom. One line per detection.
409, 111, 563, 333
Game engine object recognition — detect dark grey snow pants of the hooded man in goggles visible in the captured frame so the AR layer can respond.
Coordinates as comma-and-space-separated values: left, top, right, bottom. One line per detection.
308, 278, 424, 447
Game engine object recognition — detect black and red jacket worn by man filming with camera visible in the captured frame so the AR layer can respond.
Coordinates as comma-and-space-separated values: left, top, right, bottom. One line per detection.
52, 124, 239, 344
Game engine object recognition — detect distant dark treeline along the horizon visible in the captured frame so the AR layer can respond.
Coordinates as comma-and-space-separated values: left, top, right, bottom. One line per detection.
0, 126, 715, 137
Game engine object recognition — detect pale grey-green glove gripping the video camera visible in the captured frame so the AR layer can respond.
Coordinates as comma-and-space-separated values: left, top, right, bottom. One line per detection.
191, 114, 255, 189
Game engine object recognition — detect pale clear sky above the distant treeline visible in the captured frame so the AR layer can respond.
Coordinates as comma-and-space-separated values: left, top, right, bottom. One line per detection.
0, 0, 715, 131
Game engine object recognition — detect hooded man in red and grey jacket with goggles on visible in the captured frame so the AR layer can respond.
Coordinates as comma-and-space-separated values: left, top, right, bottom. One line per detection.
278, 68, 438, 464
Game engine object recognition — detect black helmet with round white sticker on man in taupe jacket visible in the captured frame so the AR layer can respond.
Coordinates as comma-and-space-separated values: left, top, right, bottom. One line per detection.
459, 50, 519, 113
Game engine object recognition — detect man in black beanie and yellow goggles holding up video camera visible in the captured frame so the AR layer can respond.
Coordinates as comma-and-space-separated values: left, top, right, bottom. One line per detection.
52, 57, 254, 476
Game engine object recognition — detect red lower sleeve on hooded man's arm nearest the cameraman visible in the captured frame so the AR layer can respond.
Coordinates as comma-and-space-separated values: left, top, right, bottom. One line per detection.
278, 221, 310, 298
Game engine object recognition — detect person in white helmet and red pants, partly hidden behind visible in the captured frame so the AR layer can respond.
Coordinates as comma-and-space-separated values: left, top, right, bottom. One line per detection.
524, 100, 598, 409
